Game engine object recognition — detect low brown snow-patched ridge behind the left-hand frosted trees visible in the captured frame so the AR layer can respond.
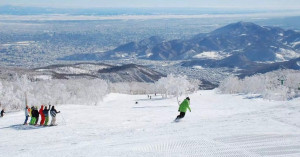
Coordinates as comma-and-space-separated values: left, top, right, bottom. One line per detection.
0, 63, 165, 82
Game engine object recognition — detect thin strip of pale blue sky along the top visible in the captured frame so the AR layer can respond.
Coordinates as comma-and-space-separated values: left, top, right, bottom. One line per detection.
0, 0, 300, 9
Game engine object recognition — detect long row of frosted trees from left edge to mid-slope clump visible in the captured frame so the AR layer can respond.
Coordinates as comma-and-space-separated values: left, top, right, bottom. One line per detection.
0, 74, 201, 110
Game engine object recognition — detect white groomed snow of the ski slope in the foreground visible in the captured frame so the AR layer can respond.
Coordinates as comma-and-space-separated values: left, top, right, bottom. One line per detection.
0, 90, 300, 157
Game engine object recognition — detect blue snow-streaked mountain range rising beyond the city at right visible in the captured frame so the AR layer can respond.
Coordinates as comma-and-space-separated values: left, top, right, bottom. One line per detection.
59, 22, 300, 62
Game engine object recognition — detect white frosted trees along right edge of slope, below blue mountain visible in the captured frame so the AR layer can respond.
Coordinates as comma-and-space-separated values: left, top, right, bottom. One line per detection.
219, 70, 300, 100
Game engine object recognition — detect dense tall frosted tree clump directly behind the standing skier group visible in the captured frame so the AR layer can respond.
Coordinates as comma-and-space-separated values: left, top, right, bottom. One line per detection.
0, 76, 108, 110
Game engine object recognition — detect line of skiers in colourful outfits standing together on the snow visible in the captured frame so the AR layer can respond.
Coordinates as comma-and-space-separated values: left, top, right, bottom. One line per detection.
24, 105, 60, 126
